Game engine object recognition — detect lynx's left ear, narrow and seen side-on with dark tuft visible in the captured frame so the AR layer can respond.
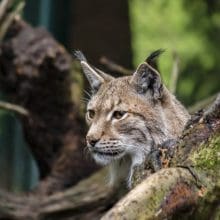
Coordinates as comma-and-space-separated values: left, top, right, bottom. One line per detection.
74, 51, 112, 92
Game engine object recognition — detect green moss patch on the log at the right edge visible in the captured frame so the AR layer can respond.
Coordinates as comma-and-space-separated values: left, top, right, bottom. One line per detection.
190, 135, 220, 171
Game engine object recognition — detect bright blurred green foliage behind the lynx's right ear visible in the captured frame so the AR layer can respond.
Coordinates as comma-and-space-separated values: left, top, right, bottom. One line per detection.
129, 0, 220, 105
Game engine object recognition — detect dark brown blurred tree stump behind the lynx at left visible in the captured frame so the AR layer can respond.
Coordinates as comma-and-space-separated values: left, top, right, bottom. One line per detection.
0, 16, 96, 193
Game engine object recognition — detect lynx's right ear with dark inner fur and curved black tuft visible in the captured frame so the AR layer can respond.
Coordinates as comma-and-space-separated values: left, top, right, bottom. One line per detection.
131, 50, 163, 100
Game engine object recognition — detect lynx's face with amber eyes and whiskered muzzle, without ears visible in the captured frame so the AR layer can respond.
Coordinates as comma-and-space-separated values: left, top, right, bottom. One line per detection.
86, 77, 156, 164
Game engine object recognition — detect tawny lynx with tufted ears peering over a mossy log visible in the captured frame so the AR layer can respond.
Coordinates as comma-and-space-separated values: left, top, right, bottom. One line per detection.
75, 50, 189, 187
